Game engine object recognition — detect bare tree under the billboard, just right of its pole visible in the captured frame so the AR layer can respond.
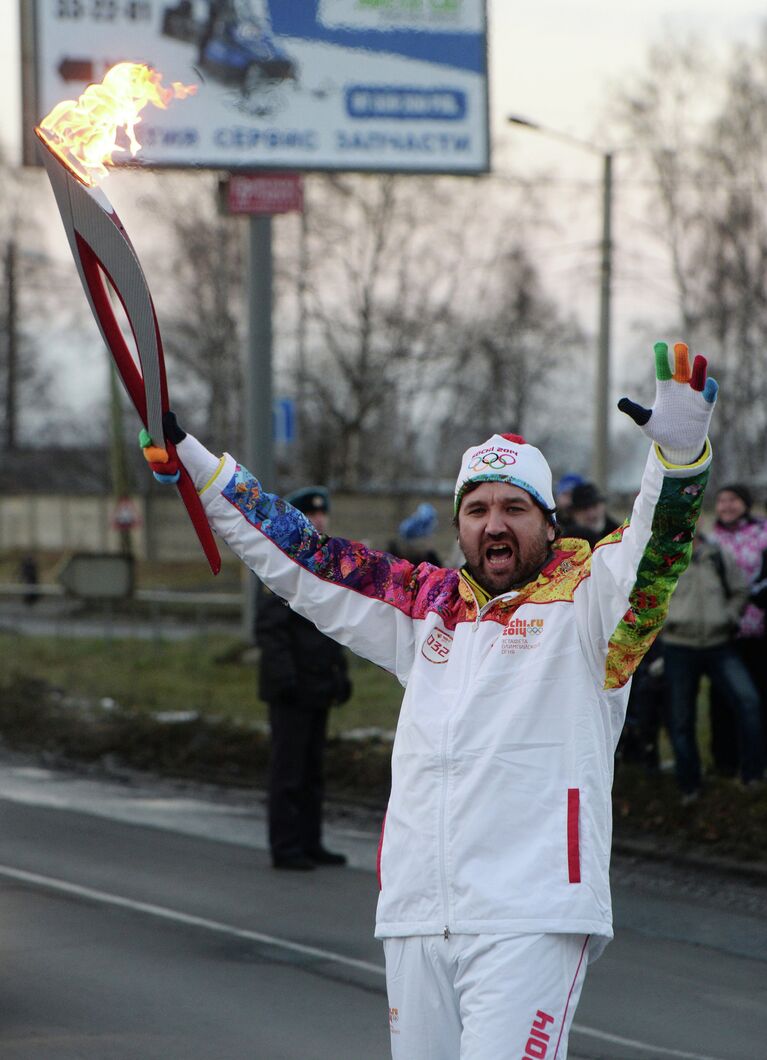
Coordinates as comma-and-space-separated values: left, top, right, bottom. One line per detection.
281, 176, 459, 488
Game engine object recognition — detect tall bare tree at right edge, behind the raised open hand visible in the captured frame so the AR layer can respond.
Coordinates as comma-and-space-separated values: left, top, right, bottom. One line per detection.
619, 32, 767, 477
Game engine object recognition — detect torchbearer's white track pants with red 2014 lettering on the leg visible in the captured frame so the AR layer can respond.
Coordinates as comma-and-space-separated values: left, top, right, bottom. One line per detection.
384, 935, 588, 1060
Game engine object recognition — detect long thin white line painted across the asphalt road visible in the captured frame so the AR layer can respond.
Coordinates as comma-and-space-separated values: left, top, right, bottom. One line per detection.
0, 865, 723, 1060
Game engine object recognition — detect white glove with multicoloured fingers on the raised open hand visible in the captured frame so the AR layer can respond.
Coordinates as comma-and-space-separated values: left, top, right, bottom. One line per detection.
618, 342, 719, 465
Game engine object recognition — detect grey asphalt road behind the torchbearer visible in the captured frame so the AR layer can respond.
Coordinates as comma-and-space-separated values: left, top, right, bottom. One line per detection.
0, 758, 767, 1060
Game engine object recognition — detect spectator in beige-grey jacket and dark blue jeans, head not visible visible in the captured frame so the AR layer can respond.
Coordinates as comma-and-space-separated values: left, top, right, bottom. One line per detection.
663, 533, 764, 805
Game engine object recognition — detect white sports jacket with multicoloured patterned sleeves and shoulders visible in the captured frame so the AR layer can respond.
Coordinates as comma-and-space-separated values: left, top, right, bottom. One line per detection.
178, 438, 711, 959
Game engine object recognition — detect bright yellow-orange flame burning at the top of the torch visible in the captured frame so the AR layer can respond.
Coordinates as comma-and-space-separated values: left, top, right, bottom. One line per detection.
37, 63, 197, 186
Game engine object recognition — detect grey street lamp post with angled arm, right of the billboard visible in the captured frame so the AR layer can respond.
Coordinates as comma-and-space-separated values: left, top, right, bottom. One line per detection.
506, 114, 612, 490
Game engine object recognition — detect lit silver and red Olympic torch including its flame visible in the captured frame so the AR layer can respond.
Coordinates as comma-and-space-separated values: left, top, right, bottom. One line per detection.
35, 63, 221, 575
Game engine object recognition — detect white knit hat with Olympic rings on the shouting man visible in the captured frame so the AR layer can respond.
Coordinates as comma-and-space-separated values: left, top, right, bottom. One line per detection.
453, 435, 554, 519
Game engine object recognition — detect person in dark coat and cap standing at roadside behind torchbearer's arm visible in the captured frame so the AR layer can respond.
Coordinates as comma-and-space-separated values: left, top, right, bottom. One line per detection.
255, 487, 352, 870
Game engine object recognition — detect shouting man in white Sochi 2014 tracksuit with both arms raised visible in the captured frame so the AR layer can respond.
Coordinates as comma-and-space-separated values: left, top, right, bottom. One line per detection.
143, 342, 717, 1060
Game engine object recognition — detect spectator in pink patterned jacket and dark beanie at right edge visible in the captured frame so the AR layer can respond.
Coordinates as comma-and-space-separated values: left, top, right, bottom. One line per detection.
711, 482, 767, 776
